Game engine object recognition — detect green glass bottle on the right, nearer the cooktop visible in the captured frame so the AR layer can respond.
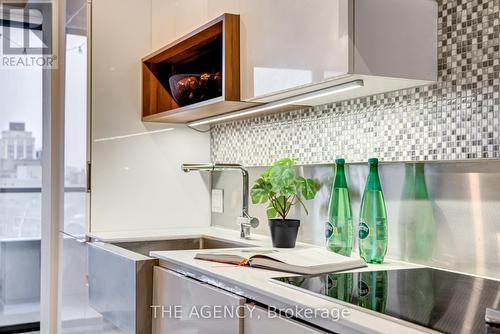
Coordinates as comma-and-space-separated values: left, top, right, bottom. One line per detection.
358, 158, 387, 263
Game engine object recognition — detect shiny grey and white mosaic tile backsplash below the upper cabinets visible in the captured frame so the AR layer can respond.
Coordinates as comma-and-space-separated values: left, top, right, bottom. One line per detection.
211, 0, 500, 166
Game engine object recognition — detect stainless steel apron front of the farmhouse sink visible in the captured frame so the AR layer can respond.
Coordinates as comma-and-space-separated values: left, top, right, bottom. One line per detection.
88, 242, 157, 334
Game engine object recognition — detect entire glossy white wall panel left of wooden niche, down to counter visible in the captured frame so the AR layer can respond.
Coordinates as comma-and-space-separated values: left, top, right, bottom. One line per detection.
90, 0, 210, 232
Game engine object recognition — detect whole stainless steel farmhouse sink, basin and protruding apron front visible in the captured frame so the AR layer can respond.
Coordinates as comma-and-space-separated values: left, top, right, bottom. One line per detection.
88, 237, 253, 334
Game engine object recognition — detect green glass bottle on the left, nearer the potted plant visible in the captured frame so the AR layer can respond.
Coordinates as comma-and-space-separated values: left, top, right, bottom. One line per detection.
326, 159, 352, 256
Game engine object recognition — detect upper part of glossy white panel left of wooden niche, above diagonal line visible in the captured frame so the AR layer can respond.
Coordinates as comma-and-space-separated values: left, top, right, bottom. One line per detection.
92, 0, 154, 139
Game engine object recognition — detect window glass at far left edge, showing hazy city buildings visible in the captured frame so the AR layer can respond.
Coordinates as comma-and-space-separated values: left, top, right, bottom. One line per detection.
0, 26, 42, 329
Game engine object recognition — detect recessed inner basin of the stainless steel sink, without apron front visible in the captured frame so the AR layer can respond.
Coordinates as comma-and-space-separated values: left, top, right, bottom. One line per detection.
112, 237, 251, 256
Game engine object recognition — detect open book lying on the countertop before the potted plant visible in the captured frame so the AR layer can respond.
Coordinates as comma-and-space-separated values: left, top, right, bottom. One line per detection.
194, 248, 366, 275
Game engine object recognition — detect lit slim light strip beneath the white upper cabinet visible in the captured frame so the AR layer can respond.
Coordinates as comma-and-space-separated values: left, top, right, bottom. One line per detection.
188, 80, 364, 127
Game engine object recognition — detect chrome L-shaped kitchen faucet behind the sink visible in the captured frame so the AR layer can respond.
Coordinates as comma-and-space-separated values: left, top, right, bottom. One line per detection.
182, 163, 259, 239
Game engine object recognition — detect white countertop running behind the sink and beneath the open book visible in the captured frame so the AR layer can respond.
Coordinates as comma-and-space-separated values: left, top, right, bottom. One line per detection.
89, 227, 432, 333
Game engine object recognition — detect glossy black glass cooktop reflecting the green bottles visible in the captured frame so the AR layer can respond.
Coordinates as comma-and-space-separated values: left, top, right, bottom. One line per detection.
274, 268, 500, 333
